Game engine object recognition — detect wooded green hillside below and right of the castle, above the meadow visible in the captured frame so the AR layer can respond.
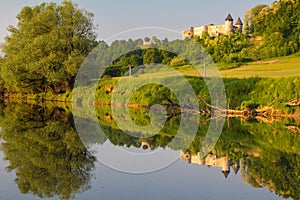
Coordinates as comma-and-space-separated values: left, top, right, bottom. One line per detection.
194, 0, 300, 65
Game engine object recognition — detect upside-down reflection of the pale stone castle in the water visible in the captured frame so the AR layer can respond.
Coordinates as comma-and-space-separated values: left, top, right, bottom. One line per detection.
180, 152, 240, 178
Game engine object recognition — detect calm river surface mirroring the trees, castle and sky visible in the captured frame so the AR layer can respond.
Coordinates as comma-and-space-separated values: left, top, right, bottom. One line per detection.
0, 103, 300, 200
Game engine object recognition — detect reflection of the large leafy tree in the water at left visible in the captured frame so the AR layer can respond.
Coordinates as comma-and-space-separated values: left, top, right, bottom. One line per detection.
0, 105, 95, 199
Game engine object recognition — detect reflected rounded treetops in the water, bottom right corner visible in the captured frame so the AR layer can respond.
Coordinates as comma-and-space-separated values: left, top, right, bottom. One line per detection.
243, 150, 300, 199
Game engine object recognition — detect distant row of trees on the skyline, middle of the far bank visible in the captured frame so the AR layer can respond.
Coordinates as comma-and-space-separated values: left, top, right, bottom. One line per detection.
96, 36, 199, 77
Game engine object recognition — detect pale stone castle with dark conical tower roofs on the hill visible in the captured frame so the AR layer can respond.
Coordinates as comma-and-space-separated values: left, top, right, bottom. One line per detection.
182, 13, 243, 39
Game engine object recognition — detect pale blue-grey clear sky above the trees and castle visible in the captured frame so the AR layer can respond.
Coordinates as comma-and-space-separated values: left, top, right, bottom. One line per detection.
0, 0, 273, 42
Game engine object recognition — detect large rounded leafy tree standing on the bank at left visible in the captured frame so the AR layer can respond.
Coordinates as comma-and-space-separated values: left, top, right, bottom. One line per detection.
1, 1, 97, 93
